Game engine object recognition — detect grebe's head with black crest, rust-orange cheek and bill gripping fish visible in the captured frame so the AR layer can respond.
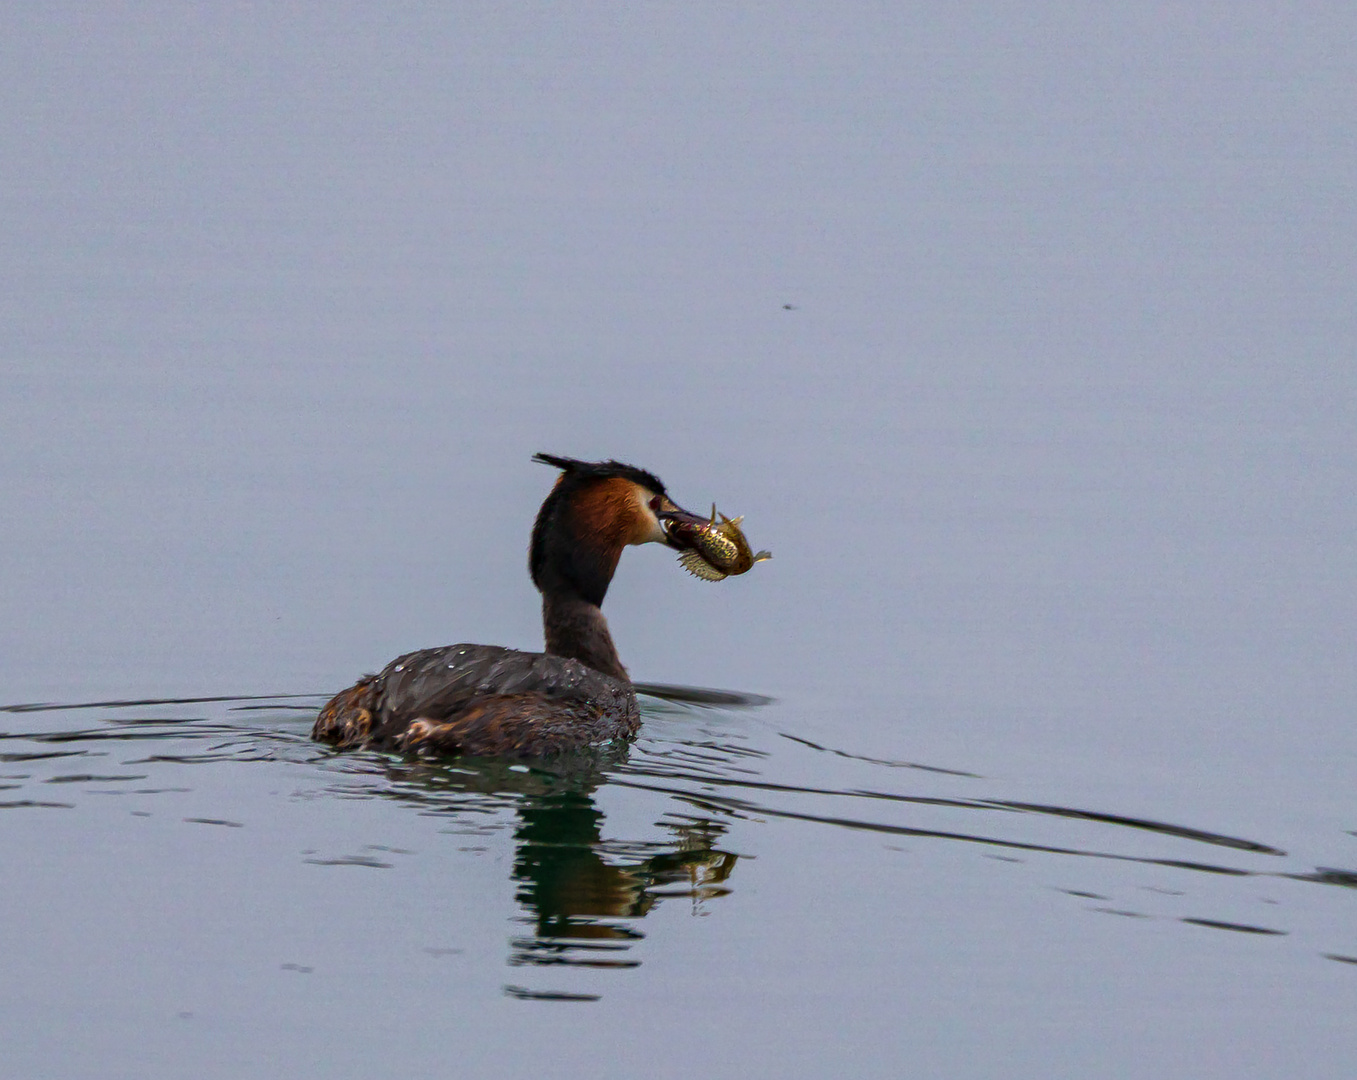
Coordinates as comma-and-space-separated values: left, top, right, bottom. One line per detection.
528, 453, 704, 606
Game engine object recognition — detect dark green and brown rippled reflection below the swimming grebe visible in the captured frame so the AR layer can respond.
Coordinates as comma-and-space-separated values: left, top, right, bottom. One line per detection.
366, 750, 738, 967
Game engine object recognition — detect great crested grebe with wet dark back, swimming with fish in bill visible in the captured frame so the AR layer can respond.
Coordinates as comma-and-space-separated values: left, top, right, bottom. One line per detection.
311, 453, 715, 757
